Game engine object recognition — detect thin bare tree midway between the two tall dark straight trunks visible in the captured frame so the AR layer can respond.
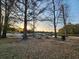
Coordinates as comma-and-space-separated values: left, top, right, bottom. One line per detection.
29, 0, 49, 37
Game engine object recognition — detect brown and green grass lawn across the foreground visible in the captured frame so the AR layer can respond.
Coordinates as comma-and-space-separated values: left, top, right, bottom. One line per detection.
0, 38, 79, 59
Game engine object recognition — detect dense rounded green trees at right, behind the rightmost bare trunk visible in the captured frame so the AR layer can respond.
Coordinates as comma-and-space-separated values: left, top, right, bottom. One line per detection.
59, 23, 79, 36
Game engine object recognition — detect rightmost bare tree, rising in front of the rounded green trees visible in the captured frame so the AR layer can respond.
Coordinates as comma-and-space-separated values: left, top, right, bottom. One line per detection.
59, 4, 69, 36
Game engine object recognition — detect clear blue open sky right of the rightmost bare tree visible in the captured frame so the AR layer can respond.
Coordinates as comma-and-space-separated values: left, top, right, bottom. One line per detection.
67, 0, 79, 24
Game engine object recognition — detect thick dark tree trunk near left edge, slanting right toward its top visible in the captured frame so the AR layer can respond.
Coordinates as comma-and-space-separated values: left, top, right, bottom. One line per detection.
2, 0, 15, 38
